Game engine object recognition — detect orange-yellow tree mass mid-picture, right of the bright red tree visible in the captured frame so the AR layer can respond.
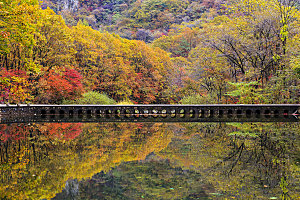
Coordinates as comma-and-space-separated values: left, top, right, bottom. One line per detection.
72, 23, 172, 103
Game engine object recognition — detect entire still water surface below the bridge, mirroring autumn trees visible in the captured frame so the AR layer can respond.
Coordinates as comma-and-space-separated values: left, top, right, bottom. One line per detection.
0, 122, 300, 200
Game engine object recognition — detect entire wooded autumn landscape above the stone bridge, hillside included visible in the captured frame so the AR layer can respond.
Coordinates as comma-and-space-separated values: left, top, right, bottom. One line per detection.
0, 0, 300, 104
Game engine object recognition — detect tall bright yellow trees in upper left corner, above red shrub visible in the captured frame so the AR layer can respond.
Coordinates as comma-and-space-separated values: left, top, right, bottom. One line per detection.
0, 0, 40, 71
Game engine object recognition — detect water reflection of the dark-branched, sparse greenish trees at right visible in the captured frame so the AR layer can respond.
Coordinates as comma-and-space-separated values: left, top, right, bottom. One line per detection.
212, 123, 300, 199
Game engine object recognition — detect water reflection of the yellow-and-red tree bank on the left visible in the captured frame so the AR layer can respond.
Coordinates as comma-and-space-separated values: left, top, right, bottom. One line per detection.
0, 123, 171, 199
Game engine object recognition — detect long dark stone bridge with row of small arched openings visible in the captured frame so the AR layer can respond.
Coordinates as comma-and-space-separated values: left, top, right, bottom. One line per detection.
0, 104, 300, 124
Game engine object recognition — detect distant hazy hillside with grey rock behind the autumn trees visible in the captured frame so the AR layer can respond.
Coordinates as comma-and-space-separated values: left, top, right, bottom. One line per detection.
42, 0, 226, 42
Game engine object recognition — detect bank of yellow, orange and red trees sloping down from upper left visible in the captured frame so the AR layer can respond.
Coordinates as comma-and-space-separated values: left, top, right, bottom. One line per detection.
0, 0, 173, 103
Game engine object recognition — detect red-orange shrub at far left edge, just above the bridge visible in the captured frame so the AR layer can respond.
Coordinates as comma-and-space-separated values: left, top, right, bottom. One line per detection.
0, 69, 32, 103
